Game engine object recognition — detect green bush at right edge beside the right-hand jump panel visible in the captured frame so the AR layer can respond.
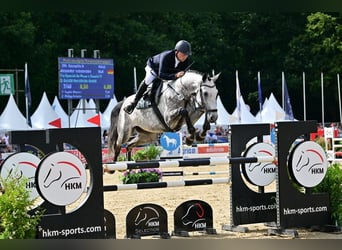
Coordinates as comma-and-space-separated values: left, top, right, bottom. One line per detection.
313, 163, 342, 226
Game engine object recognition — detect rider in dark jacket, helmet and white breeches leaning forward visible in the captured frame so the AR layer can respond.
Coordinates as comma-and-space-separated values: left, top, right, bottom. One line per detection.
124, 40, 191, 114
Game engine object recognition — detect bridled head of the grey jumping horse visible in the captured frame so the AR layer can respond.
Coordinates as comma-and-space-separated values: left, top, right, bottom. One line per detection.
196, 73, 220, 123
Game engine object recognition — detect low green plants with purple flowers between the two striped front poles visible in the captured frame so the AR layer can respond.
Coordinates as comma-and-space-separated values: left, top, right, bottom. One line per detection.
119, 168, 162, 184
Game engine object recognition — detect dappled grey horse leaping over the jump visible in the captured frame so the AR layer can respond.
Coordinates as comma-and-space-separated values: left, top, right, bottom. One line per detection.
108, 71, 220, 161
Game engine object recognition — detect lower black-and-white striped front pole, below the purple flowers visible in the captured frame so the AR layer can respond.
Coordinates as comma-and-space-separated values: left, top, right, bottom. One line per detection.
103, 178, 230, 192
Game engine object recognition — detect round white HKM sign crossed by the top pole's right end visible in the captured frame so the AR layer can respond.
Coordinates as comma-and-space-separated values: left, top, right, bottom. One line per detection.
242, 142, 276, 186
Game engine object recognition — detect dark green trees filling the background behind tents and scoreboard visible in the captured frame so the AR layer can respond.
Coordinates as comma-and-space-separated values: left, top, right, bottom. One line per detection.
0, 10, 342, 121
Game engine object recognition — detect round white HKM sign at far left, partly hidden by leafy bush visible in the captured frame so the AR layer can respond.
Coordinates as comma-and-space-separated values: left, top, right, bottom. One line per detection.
0, 152, 40, 200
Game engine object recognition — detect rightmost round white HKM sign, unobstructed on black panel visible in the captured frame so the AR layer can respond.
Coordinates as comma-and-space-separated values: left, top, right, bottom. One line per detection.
289, 141, 328, 187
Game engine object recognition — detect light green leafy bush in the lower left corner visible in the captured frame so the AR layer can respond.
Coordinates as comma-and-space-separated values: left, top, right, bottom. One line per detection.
0, 172, 43, 239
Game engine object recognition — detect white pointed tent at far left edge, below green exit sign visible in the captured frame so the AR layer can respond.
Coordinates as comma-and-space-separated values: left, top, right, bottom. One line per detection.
0, 95, 31, 130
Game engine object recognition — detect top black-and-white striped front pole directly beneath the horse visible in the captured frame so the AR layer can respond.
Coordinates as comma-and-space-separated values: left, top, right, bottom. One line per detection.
103, 156, 275, 171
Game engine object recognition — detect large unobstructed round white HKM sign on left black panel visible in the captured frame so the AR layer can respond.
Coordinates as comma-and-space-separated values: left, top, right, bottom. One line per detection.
36, 152, 87, 206
